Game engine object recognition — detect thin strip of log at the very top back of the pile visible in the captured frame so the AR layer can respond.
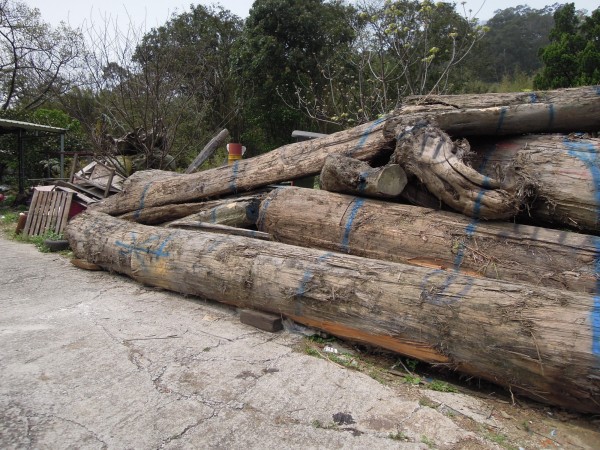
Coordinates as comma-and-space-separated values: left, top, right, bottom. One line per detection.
403, 86, 600, 109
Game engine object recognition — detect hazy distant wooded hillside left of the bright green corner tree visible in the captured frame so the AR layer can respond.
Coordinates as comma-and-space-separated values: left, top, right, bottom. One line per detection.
470, 6, 555, 83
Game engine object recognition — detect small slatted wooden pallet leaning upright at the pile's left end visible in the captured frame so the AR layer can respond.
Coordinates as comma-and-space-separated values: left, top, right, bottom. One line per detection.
23, 189, 73, 236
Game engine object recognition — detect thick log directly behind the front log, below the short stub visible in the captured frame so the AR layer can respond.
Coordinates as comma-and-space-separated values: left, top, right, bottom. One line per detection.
258, 187, 600, 292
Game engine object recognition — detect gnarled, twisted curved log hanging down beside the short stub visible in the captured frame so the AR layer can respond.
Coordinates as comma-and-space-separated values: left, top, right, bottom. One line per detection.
392, 124, 527, 219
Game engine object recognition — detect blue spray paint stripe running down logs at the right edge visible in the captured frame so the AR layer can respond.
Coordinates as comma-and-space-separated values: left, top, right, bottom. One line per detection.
564, 139, 600, 358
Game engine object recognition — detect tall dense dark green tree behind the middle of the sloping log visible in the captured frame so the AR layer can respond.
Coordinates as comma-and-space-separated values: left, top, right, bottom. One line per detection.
234, 0, 354, 152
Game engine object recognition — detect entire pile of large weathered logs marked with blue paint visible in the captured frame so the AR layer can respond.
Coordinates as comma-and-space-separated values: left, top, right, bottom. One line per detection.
67, 87, 600, 412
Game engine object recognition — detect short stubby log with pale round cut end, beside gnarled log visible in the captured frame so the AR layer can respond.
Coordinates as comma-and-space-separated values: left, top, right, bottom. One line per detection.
320, 155, 407, 198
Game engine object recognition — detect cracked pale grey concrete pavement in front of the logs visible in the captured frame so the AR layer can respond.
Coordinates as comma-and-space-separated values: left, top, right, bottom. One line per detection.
0, 236, 497, 449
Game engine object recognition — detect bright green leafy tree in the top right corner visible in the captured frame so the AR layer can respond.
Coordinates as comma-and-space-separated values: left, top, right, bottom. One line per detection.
534, 3, 600, 89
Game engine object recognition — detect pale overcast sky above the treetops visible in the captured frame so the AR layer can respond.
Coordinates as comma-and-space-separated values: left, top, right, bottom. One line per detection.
22, 0, 598, 28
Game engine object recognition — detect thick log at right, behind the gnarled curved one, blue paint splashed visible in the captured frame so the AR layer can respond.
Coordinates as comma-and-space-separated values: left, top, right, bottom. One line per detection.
472, 135, 600, 233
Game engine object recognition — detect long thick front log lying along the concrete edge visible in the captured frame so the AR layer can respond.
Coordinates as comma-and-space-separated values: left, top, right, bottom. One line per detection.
67, 209, 600, 412
